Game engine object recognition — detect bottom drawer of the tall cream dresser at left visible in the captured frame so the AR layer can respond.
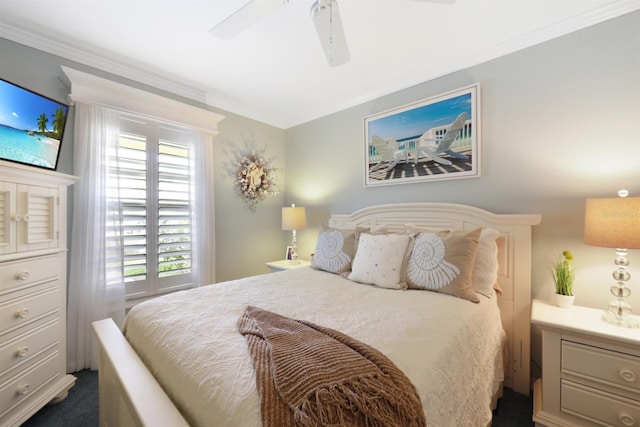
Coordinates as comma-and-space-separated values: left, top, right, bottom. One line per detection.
0, 352, 60, 419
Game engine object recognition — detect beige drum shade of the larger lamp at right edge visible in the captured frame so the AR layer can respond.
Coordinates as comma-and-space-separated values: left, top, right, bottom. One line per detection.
584, 197, 640, 249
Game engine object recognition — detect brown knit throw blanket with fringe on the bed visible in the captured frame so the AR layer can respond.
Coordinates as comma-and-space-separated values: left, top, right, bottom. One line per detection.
238, 307, 426, 427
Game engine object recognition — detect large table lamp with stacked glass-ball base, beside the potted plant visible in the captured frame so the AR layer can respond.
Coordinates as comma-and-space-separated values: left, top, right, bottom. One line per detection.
584, 190, 640, 328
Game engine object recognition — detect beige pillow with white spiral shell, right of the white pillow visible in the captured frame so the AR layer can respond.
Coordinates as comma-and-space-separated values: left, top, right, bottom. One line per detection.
407, 227, 480, 302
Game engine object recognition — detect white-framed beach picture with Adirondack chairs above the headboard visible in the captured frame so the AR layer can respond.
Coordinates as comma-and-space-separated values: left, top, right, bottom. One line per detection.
364, 84, 480, 186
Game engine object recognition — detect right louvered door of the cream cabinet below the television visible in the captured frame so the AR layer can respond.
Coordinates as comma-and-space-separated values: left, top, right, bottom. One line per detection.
15, 184, 59, 252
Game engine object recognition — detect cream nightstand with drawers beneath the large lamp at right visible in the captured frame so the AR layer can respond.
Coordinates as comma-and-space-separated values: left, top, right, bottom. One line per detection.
531, 300, 640, 426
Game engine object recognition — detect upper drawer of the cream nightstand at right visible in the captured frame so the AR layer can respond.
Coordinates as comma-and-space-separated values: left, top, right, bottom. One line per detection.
562, 341, 640, 397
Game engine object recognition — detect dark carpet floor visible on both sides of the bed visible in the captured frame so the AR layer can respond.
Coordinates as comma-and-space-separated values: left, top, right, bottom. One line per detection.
23, 370, 533, 427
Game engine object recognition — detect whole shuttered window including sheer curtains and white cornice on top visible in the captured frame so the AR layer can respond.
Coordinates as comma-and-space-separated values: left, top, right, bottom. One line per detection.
62, 67, 224, 372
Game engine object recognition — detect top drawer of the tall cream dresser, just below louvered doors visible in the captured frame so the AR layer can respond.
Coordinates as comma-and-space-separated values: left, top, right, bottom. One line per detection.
0, 255, 60, 294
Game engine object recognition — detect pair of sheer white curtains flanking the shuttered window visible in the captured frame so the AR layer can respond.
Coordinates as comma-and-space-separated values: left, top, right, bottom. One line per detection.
67, 102, 215, 372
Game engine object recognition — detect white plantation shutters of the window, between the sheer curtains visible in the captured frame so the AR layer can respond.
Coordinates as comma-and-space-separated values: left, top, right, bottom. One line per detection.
112, 118, 195, 300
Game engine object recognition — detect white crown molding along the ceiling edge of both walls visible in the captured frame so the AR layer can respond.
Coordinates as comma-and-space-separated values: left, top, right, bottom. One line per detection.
0, 0, 640, 129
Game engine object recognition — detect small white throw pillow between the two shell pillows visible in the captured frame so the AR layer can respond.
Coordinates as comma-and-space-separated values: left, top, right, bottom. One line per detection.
347, 233, 413, 289
